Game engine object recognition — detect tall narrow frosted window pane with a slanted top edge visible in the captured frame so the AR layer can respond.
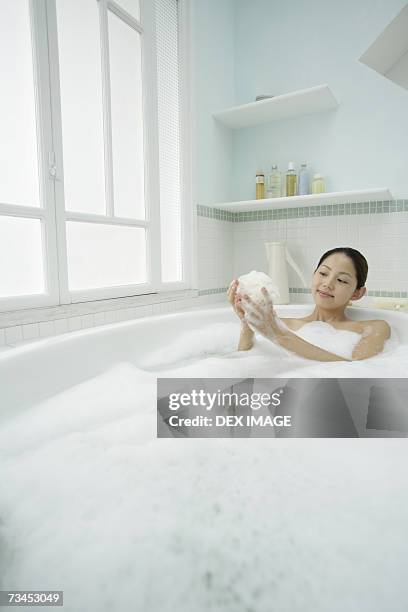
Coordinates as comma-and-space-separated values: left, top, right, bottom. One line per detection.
109, 13, 145, 219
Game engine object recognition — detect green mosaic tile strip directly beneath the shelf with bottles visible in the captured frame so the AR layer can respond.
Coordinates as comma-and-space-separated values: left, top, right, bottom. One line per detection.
197, 200, 408, 223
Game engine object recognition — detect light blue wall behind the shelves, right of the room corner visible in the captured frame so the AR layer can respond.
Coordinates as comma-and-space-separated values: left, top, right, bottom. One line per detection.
231, 0, 408, 200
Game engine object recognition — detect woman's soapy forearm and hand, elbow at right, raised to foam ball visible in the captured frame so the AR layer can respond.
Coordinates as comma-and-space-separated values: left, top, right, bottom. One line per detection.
243, 289, 349, 361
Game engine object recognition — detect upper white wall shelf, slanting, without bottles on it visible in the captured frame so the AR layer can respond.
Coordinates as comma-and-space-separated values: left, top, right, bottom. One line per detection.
213, 85, 338, 129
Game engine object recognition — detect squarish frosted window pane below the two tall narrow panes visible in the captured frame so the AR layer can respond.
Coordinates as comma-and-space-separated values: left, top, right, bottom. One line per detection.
67, 221, 146, 290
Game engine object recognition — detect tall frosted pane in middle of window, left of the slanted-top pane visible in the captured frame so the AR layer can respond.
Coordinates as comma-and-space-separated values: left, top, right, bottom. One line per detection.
56, 0, 106, 214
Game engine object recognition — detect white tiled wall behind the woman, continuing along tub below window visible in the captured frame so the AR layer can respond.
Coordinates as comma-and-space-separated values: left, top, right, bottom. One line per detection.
0, 200, 408, 349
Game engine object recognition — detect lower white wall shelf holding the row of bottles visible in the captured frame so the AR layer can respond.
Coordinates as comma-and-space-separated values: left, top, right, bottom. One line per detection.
209, 189, 393, 212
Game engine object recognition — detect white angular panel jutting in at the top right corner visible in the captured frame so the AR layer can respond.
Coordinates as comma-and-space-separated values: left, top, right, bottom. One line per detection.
360, 5, 408, 89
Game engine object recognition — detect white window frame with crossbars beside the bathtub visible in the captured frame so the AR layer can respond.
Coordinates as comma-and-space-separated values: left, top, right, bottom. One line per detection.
0, 0, 196, 311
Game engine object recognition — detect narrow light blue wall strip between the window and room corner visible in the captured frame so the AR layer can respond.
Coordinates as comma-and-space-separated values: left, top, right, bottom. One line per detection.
191, 0, 235, 204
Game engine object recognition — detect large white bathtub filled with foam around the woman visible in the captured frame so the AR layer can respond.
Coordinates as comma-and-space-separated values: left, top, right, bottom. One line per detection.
0, 306, 408, 612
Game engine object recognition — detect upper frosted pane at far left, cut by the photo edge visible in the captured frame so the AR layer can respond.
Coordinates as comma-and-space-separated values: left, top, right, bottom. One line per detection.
0, 0, 40, 206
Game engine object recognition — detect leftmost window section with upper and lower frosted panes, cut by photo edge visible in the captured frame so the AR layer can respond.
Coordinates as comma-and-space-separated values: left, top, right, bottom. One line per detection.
0, 0, 59, 310
